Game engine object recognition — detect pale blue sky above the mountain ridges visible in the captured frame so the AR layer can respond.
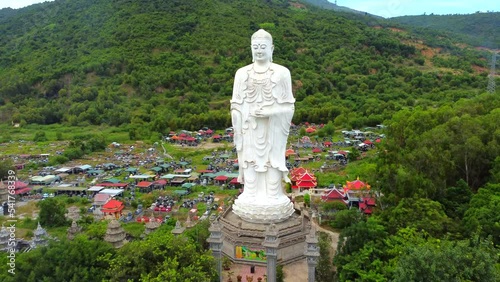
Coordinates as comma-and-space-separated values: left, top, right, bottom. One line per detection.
0, 0, 500, 18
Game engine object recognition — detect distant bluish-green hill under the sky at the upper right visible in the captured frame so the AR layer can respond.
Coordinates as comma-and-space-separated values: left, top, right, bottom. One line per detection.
390, 12, 500, 49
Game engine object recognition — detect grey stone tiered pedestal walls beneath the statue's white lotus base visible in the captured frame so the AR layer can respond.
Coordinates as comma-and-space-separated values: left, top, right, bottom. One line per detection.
219, 209, 311, 266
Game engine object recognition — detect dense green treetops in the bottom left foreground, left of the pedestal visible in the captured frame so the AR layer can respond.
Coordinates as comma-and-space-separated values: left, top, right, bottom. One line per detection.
0, 222, 218, 282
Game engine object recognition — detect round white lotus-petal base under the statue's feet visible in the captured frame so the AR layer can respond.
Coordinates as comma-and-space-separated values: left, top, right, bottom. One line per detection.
233, 194, 295, 223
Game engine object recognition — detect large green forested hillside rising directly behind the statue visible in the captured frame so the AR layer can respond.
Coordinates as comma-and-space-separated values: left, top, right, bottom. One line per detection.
0, 0, 490, 135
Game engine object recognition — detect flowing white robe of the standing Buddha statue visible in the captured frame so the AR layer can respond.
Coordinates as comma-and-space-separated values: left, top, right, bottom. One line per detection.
231, 63, 295, 189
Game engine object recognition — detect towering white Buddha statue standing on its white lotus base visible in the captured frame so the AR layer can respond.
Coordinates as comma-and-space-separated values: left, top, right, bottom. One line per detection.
231, 29, 295, 222
